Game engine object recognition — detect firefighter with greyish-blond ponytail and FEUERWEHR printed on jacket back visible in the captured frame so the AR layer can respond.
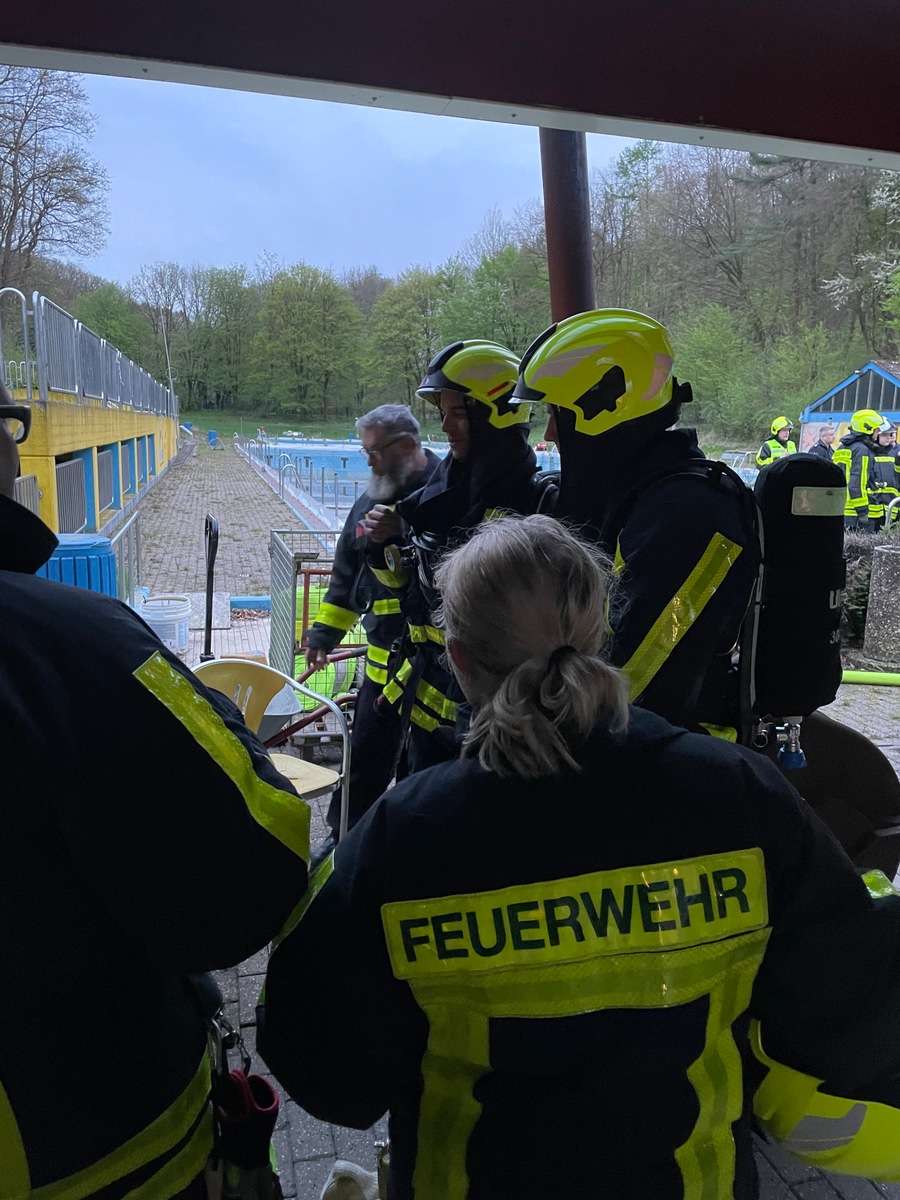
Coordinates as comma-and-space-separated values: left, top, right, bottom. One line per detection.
257, 516, 900, 1200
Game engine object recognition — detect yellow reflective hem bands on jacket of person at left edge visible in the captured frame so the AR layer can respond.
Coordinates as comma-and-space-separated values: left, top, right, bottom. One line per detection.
30, 1051, 212, 1200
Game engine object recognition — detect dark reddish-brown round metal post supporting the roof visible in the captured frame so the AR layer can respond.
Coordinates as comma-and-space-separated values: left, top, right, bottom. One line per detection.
540, 130, 596, 320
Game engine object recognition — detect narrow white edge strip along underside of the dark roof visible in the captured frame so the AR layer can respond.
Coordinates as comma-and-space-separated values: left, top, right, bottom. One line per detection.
7, 42, 900, 170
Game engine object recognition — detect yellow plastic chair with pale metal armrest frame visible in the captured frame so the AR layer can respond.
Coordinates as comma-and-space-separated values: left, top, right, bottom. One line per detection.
193, 659, 350, 838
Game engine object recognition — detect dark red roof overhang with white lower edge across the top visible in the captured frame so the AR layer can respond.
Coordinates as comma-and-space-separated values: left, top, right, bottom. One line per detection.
0, 0, 900, 169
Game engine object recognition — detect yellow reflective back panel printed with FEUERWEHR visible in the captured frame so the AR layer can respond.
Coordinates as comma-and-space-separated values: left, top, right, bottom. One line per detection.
382, 847, 769, 980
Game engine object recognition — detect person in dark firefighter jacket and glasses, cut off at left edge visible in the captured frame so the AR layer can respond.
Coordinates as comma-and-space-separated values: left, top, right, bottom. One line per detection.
0, 395, 310, 1200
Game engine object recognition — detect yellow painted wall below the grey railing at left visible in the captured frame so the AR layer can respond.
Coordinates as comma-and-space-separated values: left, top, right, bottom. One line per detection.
14, 390, 178, 530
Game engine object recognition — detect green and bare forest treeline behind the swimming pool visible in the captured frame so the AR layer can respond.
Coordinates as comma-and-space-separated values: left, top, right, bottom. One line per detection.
0, 67, 900, 438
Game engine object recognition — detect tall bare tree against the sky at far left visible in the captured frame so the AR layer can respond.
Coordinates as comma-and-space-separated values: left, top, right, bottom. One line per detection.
0, 66, 109, 287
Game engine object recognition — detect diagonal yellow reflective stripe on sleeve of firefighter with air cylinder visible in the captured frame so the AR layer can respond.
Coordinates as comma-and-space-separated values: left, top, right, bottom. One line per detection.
622, 533, 742, 701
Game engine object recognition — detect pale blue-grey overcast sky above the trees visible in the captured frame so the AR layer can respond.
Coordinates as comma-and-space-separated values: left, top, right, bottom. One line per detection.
83, 76, 629, 283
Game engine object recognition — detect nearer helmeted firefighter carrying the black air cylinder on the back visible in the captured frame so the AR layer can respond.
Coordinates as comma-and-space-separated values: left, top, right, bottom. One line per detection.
515, 308, 758, 738
